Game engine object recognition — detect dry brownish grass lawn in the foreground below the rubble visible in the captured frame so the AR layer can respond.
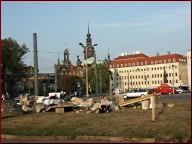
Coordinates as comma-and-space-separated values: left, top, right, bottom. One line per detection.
2, 99, 191, 141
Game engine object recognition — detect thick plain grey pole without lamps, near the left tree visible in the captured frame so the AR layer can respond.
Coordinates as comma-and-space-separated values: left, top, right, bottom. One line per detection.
33, 33, 39, 96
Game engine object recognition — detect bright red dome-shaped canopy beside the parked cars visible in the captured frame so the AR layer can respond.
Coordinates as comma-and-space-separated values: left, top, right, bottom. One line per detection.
157, 83, 176, 94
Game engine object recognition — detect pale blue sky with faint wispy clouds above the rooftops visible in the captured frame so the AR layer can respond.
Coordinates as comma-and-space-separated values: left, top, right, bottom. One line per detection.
1, 1, 191, 73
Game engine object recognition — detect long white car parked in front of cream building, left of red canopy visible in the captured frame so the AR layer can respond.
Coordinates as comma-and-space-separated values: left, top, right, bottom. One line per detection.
123, 89, 148, 99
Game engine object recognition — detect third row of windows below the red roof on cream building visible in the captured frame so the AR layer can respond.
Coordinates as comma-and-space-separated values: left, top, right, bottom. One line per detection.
114, 79, 178, 86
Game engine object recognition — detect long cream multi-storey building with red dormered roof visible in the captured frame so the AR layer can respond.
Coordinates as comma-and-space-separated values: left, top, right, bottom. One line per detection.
109, 52, 187, 91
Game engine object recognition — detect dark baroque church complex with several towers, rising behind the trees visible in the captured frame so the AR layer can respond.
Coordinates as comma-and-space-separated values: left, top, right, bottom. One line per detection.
54, 26, 110, 77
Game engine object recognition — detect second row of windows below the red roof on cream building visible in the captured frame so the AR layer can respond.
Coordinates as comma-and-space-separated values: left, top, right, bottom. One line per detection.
117, 73, 177, 80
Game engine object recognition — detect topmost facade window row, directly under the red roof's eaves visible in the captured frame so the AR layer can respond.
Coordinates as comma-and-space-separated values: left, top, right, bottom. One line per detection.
118, 66, 177, 73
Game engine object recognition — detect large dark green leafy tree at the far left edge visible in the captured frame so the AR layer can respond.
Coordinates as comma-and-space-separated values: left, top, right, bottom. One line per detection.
1, 38, 29, 96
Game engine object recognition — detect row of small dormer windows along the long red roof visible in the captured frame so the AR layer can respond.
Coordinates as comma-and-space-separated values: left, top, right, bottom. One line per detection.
110, 58, 183, 68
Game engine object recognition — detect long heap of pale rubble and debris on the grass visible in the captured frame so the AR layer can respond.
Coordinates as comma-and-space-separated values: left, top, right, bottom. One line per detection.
1, 95, 119, 113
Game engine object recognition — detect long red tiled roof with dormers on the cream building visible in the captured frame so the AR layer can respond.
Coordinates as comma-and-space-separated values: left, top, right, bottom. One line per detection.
109, 53, 186, 68
